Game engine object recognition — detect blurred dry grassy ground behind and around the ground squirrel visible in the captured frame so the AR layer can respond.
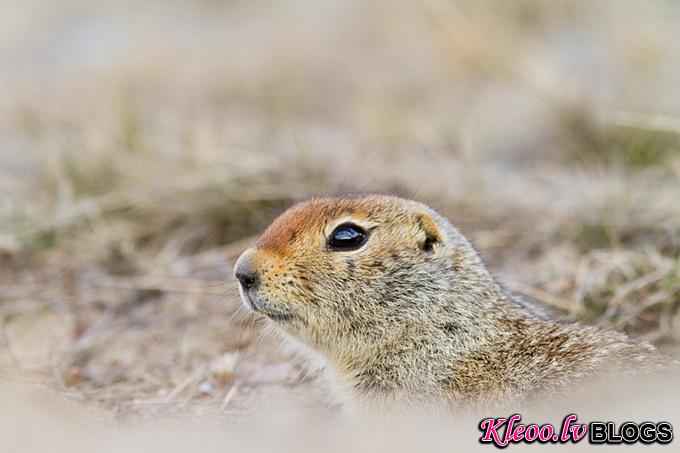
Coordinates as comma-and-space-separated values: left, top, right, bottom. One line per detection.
0, 0, 680, 422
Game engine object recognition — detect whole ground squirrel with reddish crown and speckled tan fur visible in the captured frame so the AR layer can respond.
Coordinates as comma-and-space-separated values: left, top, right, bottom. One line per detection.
235, 195, 666, 408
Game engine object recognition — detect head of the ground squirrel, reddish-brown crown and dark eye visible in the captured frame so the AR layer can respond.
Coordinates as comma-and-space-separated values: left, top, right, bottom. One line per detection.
235, 195, 491, 356
